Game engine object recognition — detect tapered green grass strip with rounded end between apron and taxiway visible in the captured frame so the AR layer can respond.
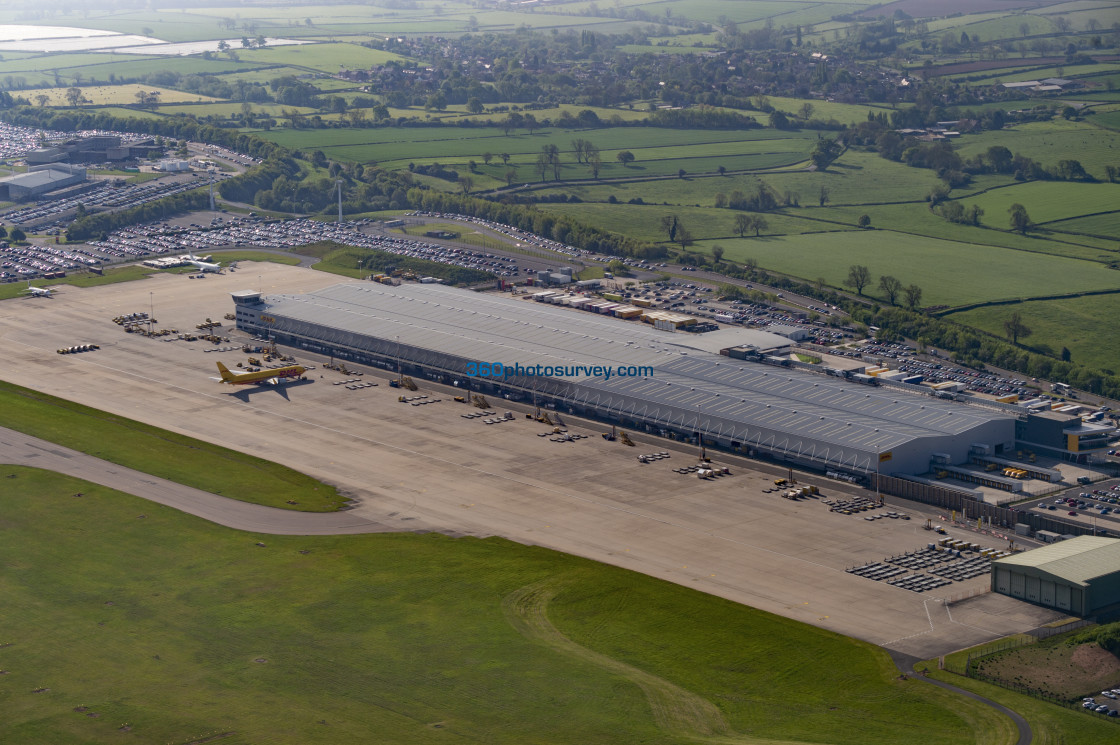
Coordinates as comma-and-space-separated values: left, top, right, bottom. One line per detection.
0, 380, 343, 508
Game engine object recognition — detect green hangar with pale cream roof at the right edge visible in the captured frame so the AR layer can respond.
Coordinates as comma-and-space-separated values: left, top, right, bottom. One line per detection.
991, 536, 1120, 616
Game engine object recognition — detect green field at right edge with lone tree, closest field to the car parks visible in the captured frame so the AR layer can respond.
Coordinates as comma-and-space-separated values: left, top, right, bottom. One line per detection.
948, 291, 1120, 372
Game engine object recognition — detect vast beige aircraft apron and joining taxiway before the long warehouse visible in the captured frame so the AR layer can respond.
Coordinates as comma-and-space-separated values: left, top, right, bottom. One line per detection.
0, 262, 1058, 659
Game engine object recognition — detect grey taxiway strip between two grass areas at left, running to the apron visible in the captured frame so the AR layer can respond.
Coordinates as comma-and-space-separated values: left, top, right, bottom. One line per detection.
0, 427, 405, 536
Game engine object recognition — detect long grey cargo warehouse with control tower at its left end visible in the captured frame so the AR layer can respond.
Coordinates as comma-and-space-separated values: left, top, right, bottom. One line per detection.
233, 283, 1015, 475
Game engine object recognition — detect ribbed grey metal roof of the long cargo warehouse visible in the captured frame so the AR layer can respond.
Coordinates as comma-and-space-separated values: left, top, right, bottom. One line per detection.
262, 283, 1010, 453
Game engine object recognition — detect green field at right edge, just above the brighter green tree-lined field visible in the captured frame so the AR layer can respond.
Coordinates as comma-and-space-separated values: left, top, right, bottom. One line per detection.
959, 119, 1120, 180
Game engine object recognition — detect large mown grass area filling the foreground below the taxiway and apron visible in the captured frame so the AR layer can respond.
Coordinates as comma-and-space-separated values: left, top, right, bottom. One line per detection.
0, 466, 1015, 745
